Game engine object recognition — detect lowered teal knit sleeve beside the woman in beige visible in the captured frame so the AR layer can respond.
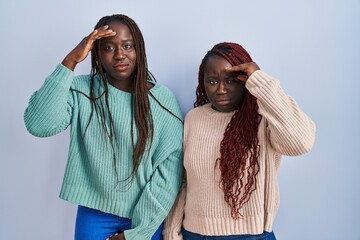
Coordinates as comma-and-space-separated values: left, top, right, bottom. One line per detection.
124, 86, 183, 240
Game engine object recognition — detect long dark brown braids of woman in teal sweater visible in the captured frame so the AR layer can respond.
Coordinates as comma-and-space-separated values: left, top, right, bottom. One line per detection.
84, 14, 156, 180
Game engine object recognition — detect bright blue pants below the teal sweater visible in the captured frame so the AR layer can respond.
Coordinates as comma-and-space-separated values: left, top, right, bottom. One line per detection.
75, 206, 163, 240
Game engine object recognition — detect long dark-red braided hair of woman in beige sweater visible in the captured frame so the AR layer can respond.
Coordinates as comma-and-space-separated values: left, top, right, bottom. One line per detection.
194, 42, 261, 219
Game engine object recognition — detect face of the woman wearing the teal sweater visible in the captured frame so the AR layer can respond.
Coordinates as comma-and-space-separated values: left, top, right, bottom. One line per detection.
100, 22, 136, 90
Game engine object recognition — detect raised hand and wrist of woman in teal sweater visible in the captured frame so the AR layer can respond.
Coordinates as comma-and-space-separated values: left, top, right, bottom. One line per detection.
62, 25, 116, 71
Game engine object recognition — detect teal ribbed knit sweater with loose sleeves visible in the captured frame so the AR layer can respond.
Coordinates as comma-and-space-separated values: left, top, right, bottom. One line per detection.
24, 64, 183, 240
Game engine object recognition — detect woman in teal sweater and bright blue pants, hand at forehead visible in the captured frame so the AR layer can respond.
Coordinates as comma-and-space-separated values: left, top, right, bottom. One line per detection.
24, 15, 183, 240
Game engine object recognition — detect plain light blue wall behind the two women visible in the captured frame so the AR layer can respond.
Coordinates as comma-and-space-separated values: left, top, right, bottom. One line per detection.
0, 0, 360, 240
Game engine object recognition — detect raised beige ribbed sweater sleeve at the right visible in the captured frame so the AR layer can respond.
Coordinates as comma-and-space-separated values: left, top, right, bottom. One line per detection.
246, 70, 316, 156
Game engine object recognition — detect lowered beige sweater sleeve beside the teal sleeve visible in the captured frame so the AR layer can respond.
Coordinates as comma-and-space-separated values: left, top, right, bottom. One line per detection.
163, 177, 186, 240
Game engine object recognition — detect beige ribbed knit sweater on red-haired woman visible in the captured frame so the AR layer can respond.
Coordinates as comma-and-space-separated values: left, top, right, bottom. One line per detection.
163, 70, 315, 240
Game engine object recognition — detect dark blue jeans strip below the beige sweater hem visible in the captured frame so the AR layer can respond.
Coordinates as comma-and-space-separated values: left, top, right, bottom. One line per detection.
181, 229, 276, 240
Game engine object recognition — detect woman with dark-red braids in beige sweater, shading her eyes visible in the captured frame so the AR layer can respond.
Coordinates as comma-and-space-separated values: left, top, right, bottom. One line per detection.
163, 43, 315, 240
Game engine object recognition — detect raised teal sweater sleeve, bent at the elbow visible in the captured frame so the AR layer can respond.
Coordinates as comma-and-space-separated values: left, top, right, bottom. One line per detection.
24, 64, 74, 137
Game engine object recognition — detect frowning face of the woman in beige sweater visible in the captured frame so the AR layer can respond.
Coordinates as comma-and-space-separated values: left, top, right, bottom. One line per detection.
204, 56, 245, 112
